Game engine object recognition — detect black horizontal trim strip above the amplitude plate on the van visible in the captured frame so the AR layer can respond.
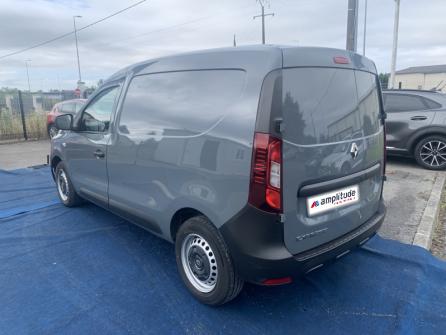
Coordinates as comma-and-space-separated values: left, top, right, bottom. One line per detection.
297, 163, 381, 197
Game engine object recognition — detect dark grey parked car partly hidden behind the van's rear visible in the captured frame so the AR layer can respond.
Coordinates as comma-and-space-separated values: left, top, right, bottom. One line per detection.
383, 90, 446, 170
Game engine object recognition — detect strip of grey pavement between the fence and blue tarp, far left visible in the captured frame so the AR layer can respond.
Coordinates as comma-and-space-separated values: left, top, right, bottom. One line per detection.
0, 140, 50, 170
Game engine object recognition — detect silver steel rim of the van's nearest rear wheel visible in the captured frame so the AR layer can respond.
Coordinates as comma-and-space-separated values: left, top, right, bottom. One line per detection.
181, 234, 218, 293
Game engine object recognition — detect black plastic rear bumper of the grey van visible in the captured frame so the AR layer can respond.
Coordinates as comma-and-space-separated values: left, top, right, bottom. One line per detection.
220, 200, 386, 284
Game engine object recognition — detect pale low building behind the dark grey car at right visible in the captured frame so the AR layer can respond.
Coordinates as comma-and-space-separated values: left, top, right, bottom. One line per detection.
394, 64, 446, 92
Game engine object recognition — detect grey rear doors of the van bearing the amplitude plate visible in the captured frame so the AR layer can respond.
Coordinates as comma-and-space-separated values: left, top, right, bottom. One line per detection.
282, 67, 384, 254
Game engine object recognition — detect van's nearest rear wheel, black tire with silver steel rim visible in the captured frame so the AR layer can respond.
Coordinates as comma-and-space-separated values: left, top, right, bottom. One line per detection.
175, 216, 243, 306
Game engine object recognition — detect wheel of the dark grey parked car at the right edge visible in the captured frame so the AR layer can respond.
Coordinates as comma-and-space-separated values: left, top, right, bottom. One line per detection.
414, 135, 446, 170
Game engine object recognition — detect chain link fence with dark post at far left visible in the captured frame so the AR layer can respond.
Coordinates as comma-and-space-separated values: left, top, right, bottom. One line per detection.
0, 90, 74, 143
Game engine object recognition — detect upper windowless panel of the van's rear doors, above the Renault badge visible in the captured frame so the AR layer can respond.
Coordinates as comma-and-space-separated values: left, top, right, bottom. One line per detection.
283, 68, 380, 144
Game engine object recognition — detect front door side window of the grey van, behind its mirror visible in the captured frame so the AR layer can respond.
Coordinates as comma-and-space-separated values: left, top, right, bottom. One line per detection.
80, 86, 119, 132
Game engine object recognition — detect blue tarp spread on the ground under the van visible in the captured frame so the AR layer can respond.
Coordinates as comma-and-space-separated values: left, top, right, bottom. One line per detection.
0, 169, 446, 335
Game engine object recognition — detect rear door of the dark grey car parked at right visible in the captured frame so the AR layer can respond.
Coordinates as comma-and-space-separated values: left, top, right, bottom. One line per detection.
383, 93, 441, 149
